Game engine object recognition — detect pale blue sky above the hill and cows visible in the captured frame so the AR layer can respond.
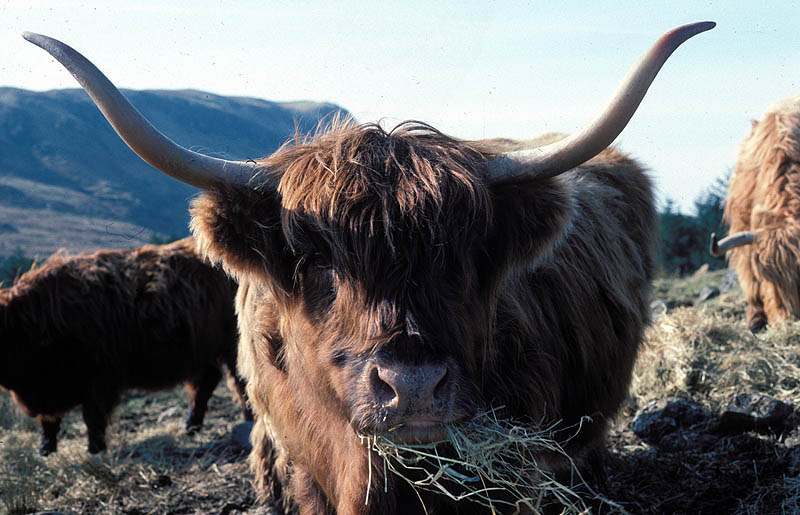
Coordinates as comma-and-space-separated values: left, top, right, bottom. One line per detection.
0, 0, 800, 212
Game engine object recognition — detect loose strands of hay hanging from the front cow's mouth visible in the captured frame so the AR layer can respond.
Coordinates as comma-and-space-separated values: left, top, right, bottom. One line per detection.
361, 408, 620, 513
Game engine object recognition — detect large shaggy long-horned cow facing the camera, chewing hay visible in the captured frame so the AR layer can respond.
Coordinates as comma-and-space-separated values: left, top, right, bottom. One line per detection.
25, 23, 713, 514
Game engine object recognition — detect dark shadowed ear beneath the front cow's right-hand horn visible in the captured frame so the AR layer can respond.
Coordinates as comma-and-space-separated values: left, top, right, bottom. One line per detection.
488, 177, 575, 267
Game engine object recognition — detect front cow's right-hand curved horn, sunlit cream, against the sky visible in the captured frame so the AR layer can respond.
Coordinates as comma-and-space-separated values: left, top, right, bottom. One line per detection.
489, 21, 716, 178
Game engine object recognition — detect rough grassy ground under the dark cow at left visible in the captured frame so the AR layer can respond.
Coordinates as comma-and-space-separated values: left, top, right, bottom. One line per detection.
0, 385, 255, 514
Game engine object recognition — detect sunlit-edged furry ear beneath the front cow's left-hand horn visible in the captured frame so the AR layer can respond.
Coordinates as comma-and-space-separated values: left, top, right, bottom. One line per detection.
191, 184, 288, 286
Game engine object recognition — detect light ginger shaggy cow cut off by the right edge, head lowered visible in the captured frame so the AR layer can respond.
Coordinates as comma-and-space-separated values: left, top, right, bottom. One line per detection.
711, 95, 800, 332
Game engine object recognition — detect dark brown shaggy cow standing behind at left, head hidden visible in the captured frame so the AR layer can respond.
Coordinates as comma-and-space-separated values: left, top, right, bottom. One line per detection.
0, 238, 252, 454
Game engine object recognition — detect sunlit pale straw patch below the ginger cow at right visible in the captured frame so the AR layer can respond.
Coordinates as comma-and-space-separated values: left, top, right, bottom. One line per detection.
631, 272, 800, 410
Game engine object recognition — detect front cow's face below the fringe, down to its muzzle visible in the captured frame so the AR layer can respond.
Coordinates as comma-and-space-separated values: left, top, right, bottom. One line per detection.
282, 207, 489, 439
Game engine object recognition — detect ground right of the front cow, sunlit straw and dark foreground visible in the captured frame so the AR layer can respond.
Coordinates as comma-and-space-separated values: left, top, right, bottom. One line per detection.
604, 272, 800, 514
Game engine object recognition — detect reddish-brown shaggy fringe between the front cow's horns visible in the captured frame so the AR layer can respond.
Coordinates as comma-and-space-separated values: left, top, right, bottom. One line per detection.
263, 119, 491, 254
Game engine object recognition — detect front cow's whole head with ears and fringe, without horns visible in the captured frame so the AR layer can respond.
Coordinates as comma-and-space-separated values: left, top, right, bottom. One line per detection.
193, 126, 571, 441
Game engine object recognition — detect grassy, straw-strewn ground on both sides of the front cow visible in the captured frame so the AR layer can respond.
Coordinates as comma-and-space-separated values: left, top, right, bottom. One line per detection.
0, 272, 800, 514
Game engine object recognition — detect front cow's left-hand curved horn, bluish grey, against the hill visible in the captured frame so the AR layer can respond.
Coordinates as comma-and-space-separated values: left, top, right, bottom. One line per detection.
22, 32, 255, 189
